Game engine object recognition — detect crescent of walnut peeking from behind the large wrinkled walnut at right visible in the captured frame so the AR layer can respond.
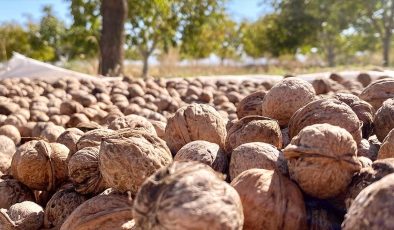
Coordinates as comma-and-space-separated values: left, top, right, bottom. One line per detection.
334, 93, 375, 138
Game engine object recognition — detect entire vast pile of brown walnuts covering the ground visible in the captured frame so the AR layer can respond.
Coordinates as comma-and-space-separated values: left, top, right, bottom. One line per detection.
0, 73, 394, 230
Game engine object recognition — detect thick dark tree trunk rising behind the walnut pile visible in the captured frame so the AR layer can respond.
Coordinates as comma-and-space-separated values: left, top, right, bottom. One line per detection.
99, 0, 127, 75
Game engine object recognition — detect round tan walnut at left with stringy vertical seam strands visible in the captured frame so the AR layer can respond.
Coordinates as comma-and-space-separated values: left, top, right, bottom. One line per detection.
11, 140, 69, 191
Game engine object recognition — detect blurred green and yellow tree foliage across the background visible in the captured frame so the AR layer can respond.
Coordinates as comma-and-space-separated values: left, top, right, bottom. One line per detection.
0, 0, 394, 74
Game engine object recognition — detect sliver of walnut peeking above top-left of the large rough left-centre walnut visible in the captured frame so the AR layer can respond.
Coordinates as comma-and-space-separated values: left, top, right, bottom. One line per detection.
77, 128, 115, 150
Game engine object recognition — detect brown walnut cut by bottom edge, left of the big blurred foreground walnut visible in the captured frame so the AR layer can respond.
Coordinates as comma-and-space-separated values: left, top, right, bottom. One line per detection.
60, 192, 133, 230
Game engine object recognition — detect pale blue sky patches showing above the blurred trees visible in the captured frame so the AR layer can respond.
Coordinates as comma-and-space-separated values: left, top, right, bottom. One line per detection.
0, 0, 270, 23
